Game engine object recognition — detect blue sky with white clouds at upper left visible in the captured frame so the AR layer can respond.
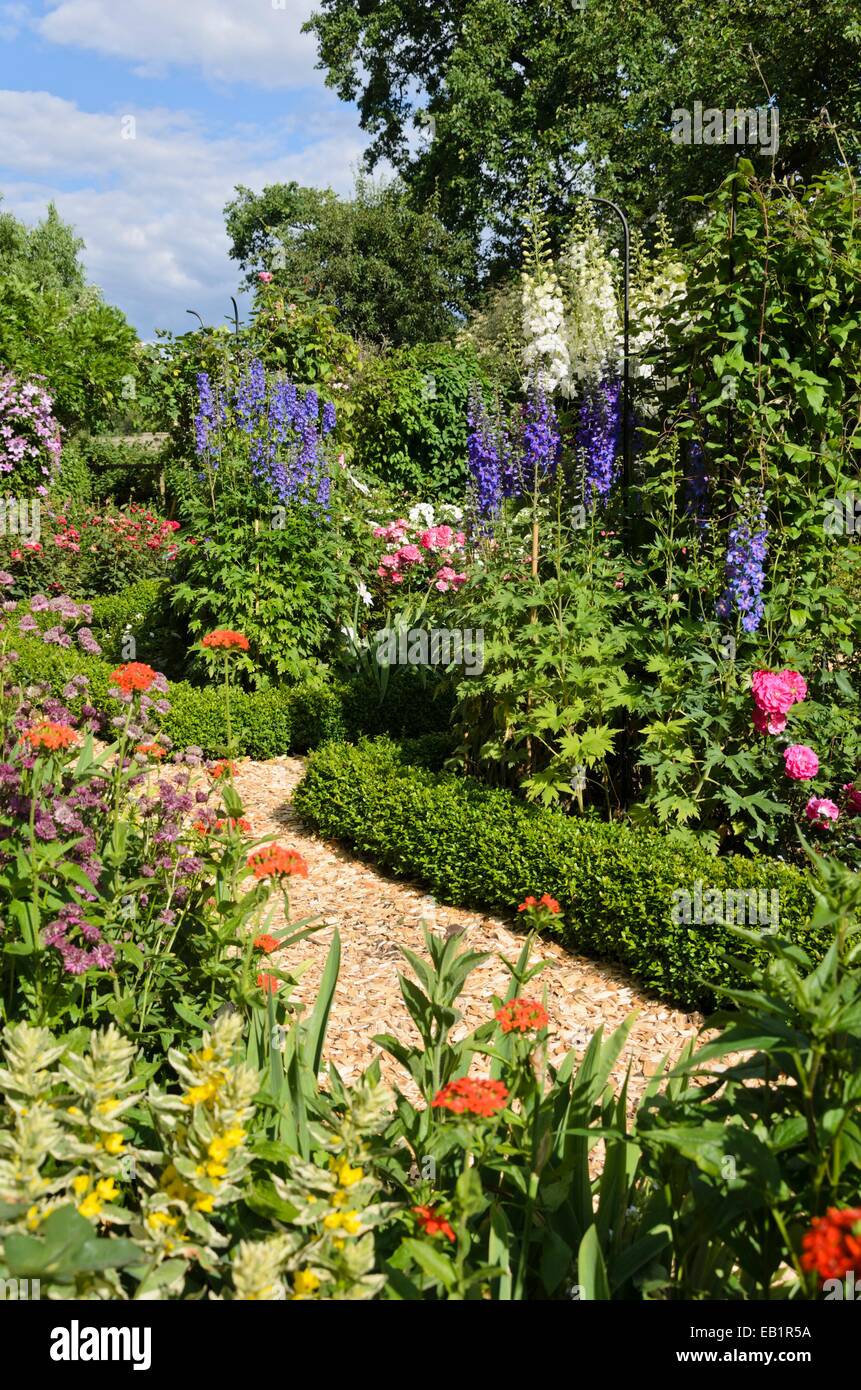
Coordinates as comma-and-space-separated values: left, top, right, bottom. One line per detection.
0, 0, 367, 338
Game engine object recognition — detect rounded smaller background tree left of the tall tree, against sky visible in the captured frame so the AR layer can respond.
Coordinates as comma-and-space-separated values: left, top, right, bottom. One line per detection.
225, 178, 474, 346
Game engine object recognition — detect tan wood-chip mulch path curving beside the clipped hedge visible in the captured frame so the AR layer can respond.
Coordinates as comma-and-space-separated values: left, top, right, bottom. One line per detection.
235, 758, 702, 1102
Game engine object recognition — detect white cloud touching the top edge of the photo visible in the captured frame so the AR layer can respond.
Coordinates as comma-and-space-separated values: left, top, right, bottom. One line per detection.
38, 0, 323, 88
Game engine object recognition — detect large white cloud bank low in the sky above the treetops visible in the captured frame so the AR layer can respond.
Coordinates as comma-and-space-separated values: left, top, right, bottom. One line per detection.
0, 92, 363, 338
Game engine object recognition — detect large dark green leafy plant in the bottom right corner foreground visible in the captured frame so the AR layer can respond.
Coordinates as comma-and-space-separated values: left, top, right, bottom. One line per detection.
637, 860, 861, 1300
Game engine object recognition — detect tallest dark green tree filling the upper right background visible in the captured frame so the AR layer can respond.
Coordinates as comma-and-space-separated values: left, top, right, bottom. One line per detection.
307, 0, 861, 268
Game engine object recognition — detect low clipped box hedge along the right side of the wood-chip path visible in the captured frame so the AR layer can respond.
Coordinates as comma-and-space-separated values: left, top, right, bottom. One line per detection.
295, 739, 826, 1008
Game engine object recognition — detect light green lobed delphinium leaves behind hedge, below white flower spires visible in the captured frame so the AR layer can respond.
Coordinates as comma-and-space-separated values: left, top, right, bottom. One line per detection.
451, 494, 634, 809
